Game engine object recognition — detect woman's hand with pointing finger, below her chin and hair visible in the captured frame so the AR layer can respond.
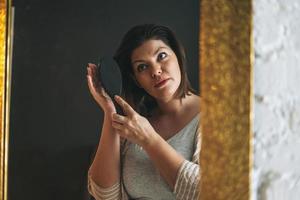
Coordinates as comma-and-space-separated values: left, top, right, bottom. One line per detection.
112, 96, 158, 147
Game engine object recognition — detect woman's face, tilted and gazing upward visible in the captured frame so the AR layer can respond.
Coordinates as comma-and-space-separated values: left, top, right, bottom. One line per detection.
131, 39, 181, 101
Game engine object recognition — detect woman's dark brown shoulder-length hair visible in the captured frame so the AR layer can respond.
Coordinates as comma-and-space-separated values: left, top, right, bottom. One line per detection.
114, 24, 195, 116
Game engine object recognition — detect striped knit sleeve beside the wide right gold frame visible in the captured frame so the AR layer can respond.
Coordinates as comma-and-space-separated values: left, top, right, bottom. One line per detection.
173, 128, 201, 200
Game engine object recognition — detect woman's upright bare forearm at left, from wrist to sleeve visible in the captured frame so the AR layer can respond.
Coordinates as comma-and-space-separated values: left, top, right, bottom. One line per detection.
89, 115, 120, 188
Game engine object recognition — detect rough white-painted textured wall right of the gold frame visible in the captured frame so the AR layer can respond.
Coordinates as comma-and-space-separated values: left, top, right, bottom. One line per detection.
252, 0, 300, 200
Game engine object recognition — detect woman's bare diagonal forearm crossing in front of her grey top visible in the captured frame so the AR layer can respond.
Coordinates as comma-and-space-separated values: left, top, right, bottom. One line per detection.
143, 135, 185, 190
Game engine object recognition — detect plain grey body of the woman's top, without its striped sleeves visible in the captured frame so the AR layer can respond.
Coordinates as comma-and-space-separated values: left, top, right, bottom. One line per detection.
123, 115, 199, 200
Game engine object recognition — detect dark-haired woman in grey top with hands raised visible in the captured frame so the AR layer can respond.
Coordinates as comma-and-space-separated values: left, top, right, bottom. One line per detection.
87, 24, 200, 199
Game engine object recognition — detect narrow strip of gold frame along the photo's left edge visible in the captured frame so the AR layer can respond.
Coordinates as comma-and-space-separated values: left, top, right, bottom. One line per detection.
0, 0, 13, 200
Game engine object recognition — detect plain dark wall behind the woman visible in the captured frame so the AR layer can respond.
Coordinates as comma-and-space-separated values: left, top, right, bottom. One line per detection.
8, 0, 199, 200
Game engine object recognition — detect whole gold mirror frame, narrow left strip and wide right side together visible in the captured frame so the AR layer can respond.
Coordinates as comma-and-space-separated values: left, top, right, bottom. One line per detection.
0, 0, 253, 200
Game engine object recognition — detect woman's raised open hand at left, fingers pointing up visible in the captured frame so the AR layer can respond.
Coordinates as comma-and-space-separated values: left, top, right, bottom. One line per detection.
87, 63, 116, 114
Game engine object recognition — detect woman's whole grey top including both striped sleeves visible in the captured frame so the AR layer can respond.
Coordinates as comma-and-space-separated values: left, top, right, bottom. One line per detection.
88, 114, 201, 200
